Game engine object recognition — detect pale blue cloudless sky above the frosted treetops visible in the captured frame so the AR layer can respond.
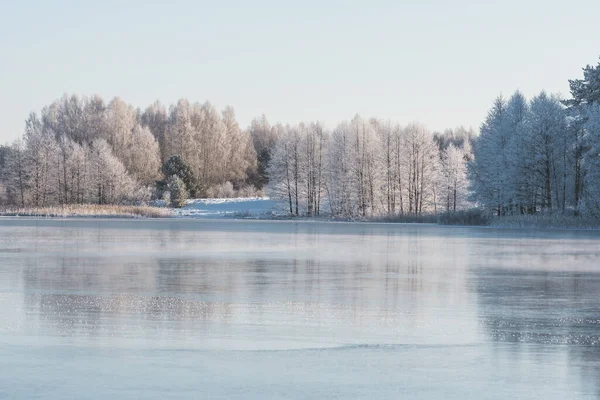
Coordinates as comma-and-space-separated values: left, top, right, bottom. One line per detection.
0, 0, 600, 143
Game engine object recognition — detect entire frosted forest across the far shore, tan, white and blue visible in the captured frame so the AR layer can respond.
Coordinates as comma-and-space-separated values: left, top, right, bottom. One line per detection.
0, 56, 600, 218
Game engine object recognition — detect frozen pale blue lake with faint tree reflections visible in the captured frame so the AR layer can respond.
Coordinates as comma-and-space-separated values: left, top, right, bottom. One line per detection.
0, 219, 600, 400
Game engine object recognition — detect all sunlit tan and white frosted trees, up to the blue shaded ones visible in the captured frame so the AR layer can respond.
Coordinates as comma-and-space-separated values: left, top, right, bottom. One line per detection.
0, 95, 475, 217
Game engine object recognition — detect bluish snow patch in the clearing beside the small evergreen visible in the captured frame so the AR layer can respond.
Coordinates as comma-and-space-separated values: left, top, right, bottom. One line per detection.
173, 197, 279, 218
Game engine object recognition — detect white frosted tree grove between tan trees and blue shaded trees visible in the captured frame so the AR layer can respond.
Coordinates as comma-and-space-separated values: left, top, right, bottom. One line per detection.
263, 116, 474, 217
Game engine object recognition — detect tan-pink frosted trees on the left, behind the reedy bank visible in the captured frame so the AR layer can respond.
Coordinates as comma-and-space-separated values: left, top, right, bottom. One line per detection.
0, 95, 256, 207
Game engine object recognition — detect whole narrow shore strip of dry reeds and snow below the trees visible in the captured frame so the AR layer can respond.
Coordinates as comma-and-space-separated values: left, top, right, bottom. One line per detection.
0, 202, 600, 231
